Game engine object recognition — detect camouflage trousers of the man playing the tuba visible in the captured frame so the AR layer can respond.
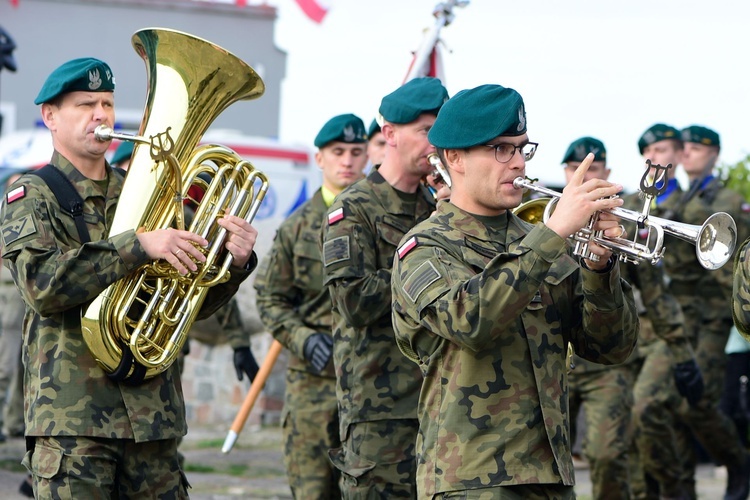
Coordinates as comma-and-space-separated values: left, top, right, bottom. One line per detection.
23, 436, 190, 500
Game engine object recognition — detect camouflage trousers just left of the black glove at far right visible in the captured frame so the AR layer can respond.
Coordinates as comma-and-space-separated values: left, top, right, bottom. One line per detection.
631, 338, 687, 500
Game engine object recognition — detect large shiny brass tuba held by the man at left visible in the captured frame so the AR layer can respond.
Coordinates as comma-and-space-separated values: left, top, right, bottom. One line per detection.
81, 28, 268, 384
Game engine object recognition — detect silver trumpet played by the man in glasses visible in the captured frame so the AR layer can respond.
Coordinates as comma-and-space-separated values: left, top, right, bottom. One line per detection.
513, 177, 737, 270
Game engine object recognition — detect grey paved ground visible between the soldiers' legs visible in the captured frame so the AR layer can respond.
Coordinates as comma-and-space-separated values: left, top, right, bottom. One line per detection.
0, 427, 725, 500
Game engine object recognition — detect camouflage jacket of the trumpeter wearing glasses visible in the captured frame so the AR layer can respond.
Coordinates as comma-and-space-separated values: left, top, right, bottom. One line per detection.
392, 202, 638, 498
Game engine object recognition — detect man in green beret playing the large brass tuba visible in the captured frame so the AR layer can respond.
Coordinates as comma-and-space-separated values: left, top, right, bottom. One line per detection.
0, 58, 257, 499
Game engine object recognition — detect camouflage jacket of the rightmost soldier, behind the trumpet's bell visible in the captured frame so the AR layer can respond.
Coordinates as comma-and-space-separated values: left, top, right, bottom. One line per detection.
653, 178, 750, 318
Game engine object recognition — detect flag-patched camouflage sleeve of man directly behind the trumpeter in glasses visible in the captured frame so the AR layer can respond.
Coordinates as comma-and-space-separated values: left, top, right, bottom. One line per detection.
322, 199, 397, 328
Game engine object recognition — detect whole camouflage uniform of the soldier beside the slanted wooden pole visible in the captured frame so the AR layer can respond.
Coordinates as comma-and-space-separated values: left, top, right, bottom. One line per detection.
255, 190, 341, 499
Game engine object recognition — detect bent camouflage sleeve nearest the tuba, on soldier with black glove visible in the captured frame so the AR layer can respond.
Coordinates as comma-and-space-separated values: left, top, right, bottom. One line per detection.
255, 230, 315, 359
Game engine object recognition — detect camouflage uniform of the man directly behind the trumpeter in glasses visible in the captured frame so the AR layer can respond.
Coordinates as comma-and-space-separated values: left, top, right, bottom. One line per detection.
323, 170, 434, 498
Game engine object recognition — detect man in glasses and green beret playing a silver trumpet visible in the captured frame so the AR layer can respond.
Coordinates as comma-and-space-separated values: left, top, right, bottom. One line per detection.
392, 85, 638, 499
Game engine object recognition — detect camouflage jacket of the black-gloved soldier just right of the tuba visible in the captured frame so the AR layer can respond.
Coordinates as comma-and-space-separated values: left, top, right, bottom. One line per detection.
255, 190, 335, 378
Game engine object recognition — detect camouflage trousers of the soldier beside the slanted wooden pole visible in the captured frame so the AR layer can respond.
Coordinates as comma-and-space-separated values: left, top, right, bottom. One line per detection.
282, 370, 341, 500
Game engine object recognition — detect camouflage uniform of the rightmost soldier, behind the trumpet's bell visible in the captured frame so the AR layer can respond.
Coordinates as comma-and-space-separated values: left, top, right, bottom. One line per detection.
654, 178, 750, 492
